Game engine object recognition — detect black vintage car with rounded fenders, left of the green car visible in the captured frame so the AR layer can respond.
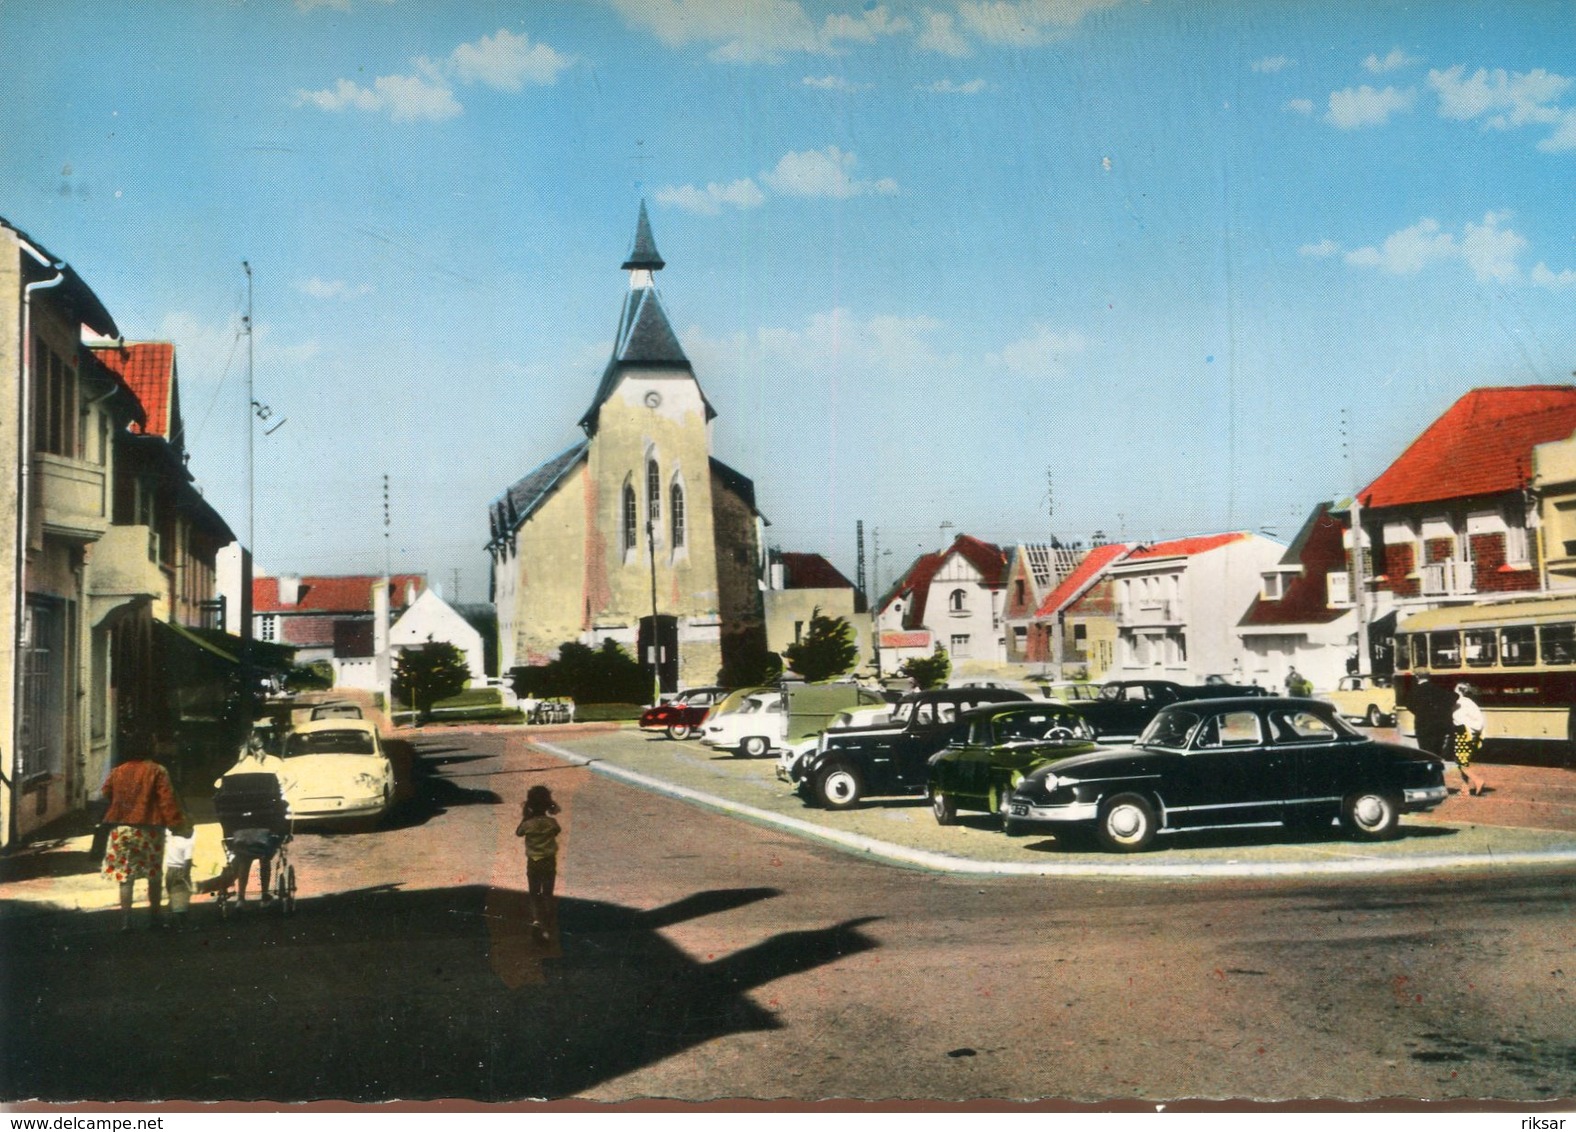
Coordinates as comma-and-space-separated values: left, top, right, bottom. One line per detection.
780, 687, 1031, 810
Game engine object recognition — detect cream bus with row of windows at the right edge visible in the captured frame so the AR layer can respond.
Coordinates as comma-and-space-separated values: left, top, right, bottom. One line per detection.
1395, 596, 1576, 747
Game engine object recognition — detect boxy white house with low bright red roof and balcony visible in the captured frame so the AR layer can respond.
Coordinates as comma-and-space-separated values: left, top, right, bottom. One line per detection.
1110, 531, 1286, 683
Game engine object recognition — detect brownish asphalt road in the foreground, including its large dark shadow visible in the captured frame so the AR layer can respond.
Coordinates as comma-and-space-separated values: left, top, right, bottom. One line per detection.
0, 732, 1576, 1105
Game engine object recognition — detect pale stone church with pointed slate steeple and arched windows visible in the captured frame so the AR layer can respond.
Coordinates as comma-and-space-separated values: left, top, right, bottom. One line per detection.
487, 203, 766, 692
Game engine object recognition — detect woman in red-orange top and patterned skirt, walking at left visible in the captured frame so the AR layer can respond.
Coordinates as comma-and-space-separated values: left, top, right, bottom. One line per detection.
99, 738, 186, 932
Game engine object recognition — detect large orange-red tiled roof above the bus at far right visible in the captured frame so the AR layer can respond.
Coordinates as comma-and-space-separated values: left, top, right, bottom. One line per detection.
1359, 385, 1576, 508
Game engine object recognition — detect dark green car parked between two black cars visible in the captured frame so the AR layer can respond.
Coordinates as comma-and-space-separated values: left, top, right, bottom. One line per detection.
927, 702, 1097, 832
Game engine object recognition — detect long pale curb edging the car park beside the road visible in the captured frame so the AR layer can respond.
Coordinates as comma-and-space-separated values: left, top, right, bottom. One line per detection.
528, 736, 1576, 880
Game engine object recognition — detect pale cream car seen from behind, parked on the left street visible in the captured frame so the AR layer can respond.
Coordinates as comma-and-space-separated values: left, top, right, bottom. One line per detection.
281, 719, 394, 821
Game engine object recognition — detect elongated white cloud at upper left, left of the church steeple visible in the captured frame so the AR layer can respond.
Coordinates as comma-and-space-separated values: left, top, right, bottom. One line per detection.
295, 28, 574, 121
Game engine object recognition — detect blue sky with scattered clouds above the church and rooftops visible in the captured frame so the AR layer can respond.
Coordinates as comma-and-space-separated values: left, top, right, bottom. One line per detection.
0, 0, 1576, 601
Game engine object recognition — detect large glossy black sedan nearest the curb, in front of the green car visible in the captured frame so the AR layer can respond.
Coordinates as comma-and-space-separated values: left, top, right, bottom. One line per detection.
1005, 697, 1447, 853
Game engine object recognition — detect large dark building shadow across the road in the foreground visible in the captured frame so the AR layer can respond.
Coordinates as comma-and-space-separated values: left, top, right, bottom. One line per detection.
0, 886, 876, 1102
